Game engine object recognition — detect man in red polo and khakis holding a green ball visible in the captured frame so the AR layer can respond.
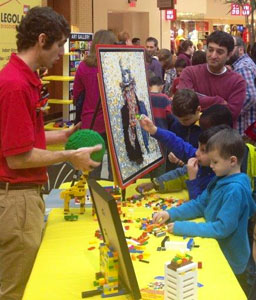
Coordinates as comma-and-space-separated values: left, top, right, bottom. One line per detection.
0, 7, 101, 300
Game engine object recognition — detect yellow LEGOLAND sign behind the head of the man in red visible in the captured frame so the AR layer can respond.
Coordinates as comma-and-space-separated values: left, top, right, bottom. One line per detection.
0, 0, 42, 69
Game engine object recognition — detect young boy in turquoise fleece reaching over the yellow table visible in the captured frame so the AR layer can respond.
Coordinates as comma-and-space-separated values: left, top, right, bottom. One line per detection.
153, 129, 256, 281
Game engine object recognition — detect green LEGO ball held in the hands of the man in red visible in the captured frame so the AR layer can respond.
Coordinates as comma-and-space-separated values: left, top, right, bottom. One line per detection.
65, 129, 106, 162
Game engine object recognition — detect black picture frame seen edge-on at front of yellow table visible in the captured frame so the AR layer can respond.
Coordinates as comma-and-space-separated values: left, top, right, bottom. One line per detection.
88, 179, 141, 300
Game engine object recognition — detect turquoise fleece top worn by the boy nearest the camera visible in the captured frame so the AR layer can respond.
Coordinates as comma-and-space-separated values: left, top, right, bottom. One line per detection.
168, 173, 256, 274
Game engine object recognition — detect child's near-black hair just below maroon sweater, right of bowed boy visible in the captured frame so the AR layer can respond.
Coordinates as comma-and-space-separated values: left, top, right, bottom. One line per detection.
199, 104, 233, 130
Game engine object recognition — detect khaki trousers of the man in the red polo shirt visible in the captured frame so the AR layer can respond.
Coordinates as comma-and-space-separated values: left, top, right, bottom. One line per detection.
0, 188, 45, 300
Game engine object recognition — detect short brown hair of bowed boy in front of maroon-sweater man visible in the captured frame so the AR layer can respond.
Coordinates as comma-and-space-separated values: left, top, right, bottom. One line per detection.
172, 89, 200, 117
